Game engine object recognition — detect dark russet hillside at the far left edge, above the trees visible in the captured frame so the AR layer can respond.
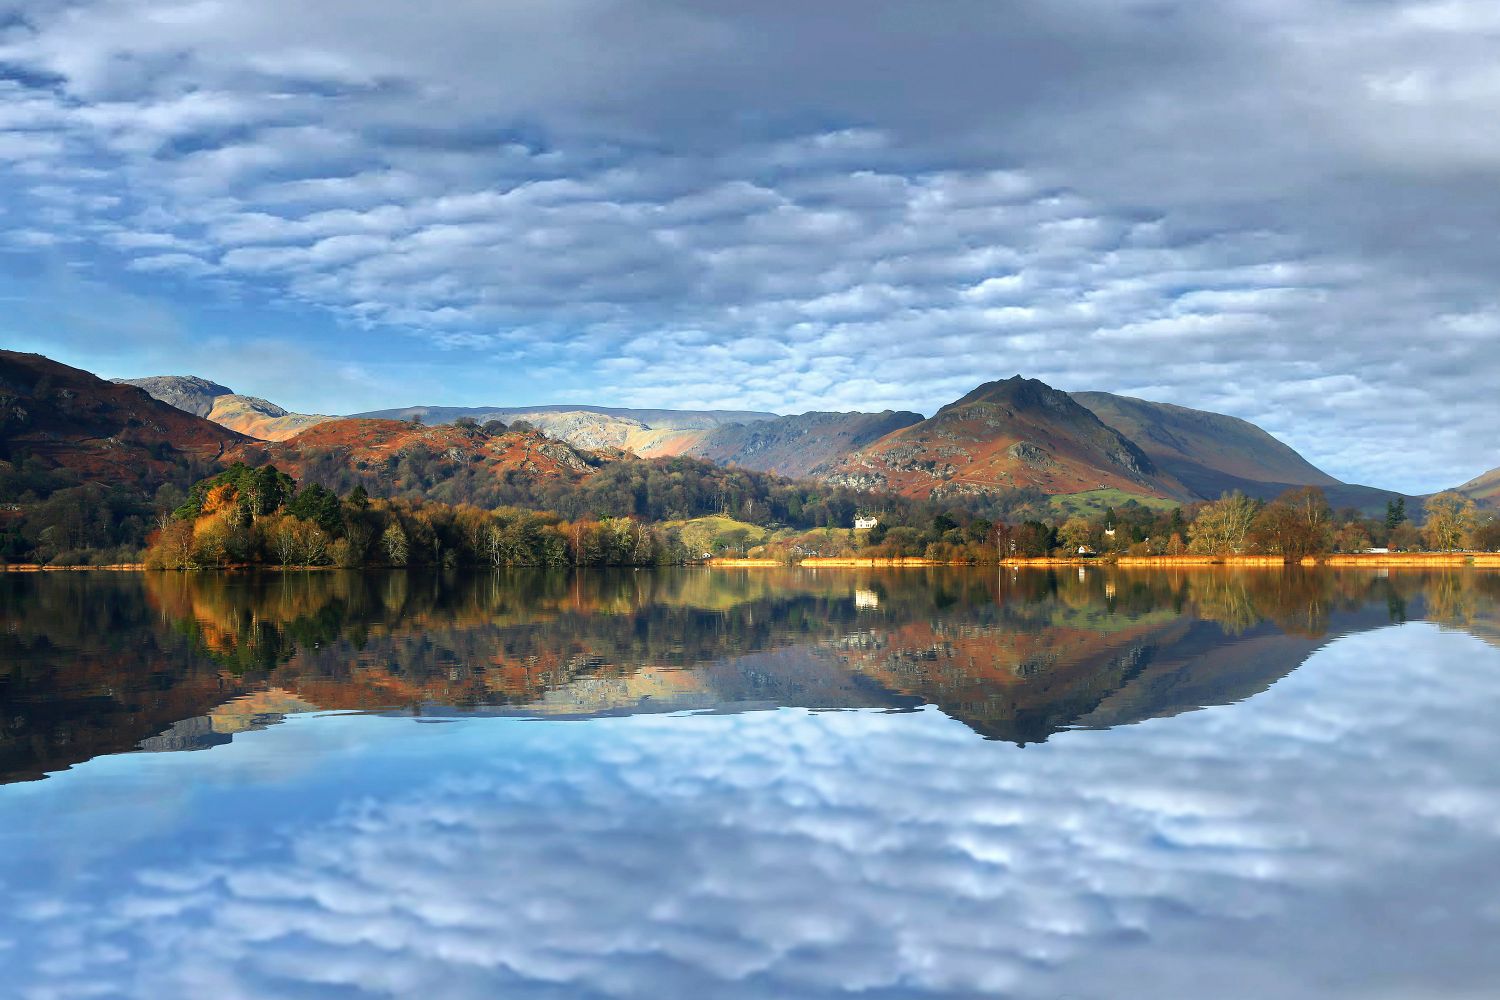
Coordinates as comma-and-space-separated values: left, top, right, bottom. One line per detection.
0, 351, 246, 489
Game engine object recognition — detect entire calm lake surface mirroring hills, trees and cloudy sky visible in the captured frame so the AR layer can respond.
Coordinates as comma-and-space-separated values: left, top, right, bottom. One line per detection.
0, 567, 1500, 1000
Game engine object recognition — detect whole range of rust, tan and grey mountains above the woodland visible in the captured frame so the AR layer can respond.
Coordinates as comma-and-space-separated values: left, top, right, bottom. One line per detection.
14, 352, 1500, 511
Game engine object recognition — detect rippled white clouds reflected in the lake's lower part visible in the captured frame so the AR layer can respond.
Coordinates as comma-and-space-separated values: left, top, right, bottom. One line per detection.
0, 625, 1500, 999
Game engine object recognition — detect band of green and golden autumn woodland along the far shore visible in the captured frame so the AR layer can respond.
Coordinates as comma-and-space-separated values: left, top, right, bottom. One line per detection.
0, 440, 1500, 568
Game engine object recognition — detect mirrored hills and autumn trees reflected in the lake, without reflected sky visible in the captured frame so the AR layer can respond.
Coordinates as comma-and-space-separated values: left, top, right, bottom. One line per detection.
0, 568, 1500, 781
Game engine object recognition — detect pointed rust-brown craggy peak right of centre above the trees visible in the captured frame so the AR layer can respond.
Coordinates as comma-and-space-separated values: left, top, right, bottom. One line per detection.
827, 375, 1191, 499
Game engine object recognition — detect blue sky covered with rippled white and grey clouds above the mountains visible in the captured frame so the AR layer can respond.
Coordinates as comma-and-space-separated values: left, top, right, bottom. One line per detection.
0, 0, 1500, 492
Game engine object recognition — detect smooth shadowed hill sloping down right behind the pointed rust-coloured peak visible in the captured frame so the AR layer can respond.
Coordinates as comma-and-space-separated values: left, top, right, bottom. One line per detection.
1073, 393, 1394, 511
